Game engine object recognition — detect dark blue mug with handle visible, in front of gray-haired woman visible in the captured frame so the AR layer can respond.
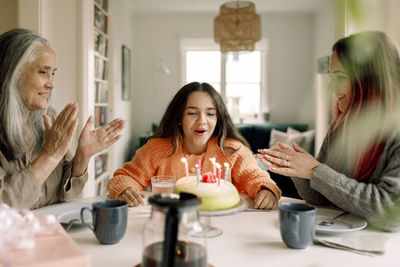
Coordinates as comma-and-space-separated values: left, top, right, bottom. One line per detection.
81, 199, 128, 245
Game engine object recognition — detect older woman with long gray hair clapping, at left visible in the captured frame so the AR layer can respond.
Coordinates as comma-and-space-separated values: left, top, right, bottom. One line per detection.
0, 29, 125, 209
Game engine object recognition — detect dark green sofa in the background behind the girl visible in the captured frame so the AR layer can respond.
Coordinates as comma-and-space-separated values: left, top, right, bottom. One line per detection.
139, 122, 314, 198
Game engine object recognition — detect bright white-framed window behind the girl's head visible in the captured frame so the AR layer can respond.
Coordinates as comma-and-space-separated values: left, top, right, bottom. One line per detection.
182, 37, 268, 122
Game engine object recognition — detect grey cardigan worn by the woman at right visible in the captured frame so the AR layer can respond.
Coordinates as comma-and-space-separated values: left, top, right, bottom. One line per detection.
292, 134, 400, 231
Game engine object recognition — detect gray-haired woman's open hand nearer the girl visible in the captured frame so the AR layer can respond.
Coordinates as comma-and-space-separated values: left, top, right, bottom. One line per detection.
72, 116, 125, 176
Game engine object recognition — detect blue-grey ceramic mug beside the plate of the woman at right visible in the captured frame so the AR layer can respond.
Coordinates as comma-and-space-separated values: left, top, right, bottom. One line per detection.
279, 203, 317, 249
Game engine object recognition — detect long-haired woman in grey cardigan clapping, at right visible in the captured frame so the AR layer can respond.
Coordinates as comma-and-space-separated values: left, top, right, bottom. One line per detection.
257, 31, 400, 231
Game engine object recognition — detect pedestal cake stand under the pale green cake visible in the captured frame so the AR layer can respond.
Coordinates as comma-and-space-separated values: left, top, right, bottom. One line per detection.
196, 196, 247, 238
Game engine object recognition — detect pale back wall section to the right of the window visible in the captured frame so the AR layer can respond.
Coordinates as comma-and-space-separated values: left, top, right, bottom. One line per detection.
262, 13, 314, 127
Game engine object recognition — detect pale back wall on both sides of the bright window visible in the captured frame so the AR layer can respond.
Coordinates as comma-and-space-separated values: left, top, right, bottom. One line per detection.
132, 13, 326, 149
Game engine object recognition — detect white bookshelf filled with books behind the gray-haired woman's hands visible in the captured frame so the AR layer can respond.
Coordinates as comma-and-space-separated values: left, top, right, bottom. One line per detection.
80, 0, 113, 196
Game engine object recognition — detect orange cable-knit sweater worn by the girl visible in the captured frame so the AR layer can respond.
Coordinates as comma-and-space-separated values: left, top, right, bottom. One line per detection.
107, 137, 281, 199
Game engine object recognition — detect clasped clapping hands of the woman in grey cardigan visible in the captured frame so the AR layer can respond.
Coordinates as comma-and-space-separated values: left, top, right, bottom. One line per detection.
256, 142, 320, 179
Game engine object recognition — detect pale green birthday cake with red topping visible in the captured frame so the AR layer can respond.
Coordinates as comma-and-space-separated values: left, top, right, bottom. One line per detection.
175, 173, 240, 211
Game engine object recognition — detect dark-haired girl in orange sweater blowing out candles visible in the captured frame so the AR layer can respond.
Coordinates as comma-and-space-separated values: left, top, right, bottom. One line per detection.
108, 82, 281, 209
